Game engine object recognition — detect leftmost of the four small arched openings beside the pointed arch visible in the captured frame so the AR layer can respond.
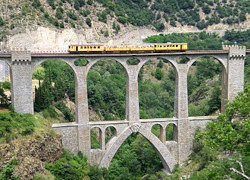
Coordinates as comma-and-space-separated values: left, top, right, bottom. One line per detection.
90, 127, 102, 149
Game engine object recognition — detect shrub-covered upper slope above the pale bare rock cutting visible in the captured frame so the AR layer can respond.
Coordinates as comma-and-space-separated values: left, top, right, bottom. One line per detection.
0, 0, 250, 40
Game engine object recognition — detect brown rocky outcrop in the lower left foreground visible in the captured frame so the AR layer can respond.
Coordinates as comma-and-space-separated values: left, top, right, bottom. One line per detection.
0, 134, 63, 180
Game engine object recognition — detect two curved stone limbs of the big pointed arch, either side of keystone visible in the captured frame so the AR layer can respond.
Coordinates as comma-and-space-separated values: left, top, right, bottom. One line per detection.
99, 127, 176, 172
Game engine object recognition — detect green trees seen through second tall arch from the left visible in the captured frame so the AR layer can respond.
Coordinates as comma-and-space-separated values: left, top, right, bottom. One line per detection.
88, 61, 127, 120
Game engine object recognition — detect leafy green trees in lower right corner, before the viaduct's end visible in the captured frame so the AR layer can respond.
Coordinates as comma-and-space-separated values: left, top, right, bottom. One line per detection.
190, 85, 250, 180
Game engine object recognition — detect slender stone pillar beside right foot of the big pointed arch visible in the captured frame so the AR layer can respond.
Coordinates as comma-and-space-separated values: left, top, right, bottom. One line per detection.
175, 64, 191, 163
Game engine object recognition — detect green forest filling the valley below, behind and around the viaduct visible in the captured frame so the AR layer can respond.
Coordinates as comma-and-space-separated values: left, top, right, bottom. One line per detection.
0, 30, 250, 180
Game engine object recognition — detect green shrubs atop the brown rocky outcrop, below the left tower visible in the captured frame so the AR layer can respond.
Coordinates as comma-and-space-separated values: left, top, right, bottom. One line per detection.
0, 112, 36, 142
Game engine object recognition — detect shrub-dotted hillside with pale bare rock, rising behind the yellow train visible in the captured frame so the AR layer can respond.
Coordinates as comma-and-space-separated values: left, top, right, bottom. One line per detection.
0, 0, 250, 50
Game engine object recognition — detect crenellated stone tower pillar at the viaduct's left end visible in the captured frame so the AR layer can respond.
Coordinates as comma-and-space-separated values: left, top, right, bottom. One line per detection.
11, 51, 34, 114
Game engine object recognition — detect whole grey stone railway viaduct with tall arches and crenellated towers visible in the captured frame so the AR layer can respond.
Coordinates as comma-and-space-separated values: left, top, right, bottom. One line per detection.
0, 45, 247, 172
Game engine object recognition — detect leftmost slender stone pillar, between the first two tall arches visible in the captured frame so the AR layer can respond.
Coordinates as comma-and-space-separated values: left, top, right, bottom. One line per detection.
75, 66, 91, 157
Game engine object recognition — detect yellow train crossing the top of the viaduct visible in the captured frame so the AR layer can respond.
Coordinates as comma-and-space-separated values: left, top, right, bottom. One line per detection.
68, 43, 188, 54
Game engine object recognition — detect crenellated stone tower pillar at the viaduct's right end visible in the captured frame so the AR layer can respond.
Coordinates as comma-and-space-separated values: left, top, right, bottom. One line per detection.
227, 45, 246, 101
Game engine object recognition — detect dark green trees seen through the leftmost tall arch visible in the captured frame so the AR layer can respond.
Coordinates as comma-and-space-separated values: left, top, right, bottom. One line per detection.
34, 60, 75, 115
